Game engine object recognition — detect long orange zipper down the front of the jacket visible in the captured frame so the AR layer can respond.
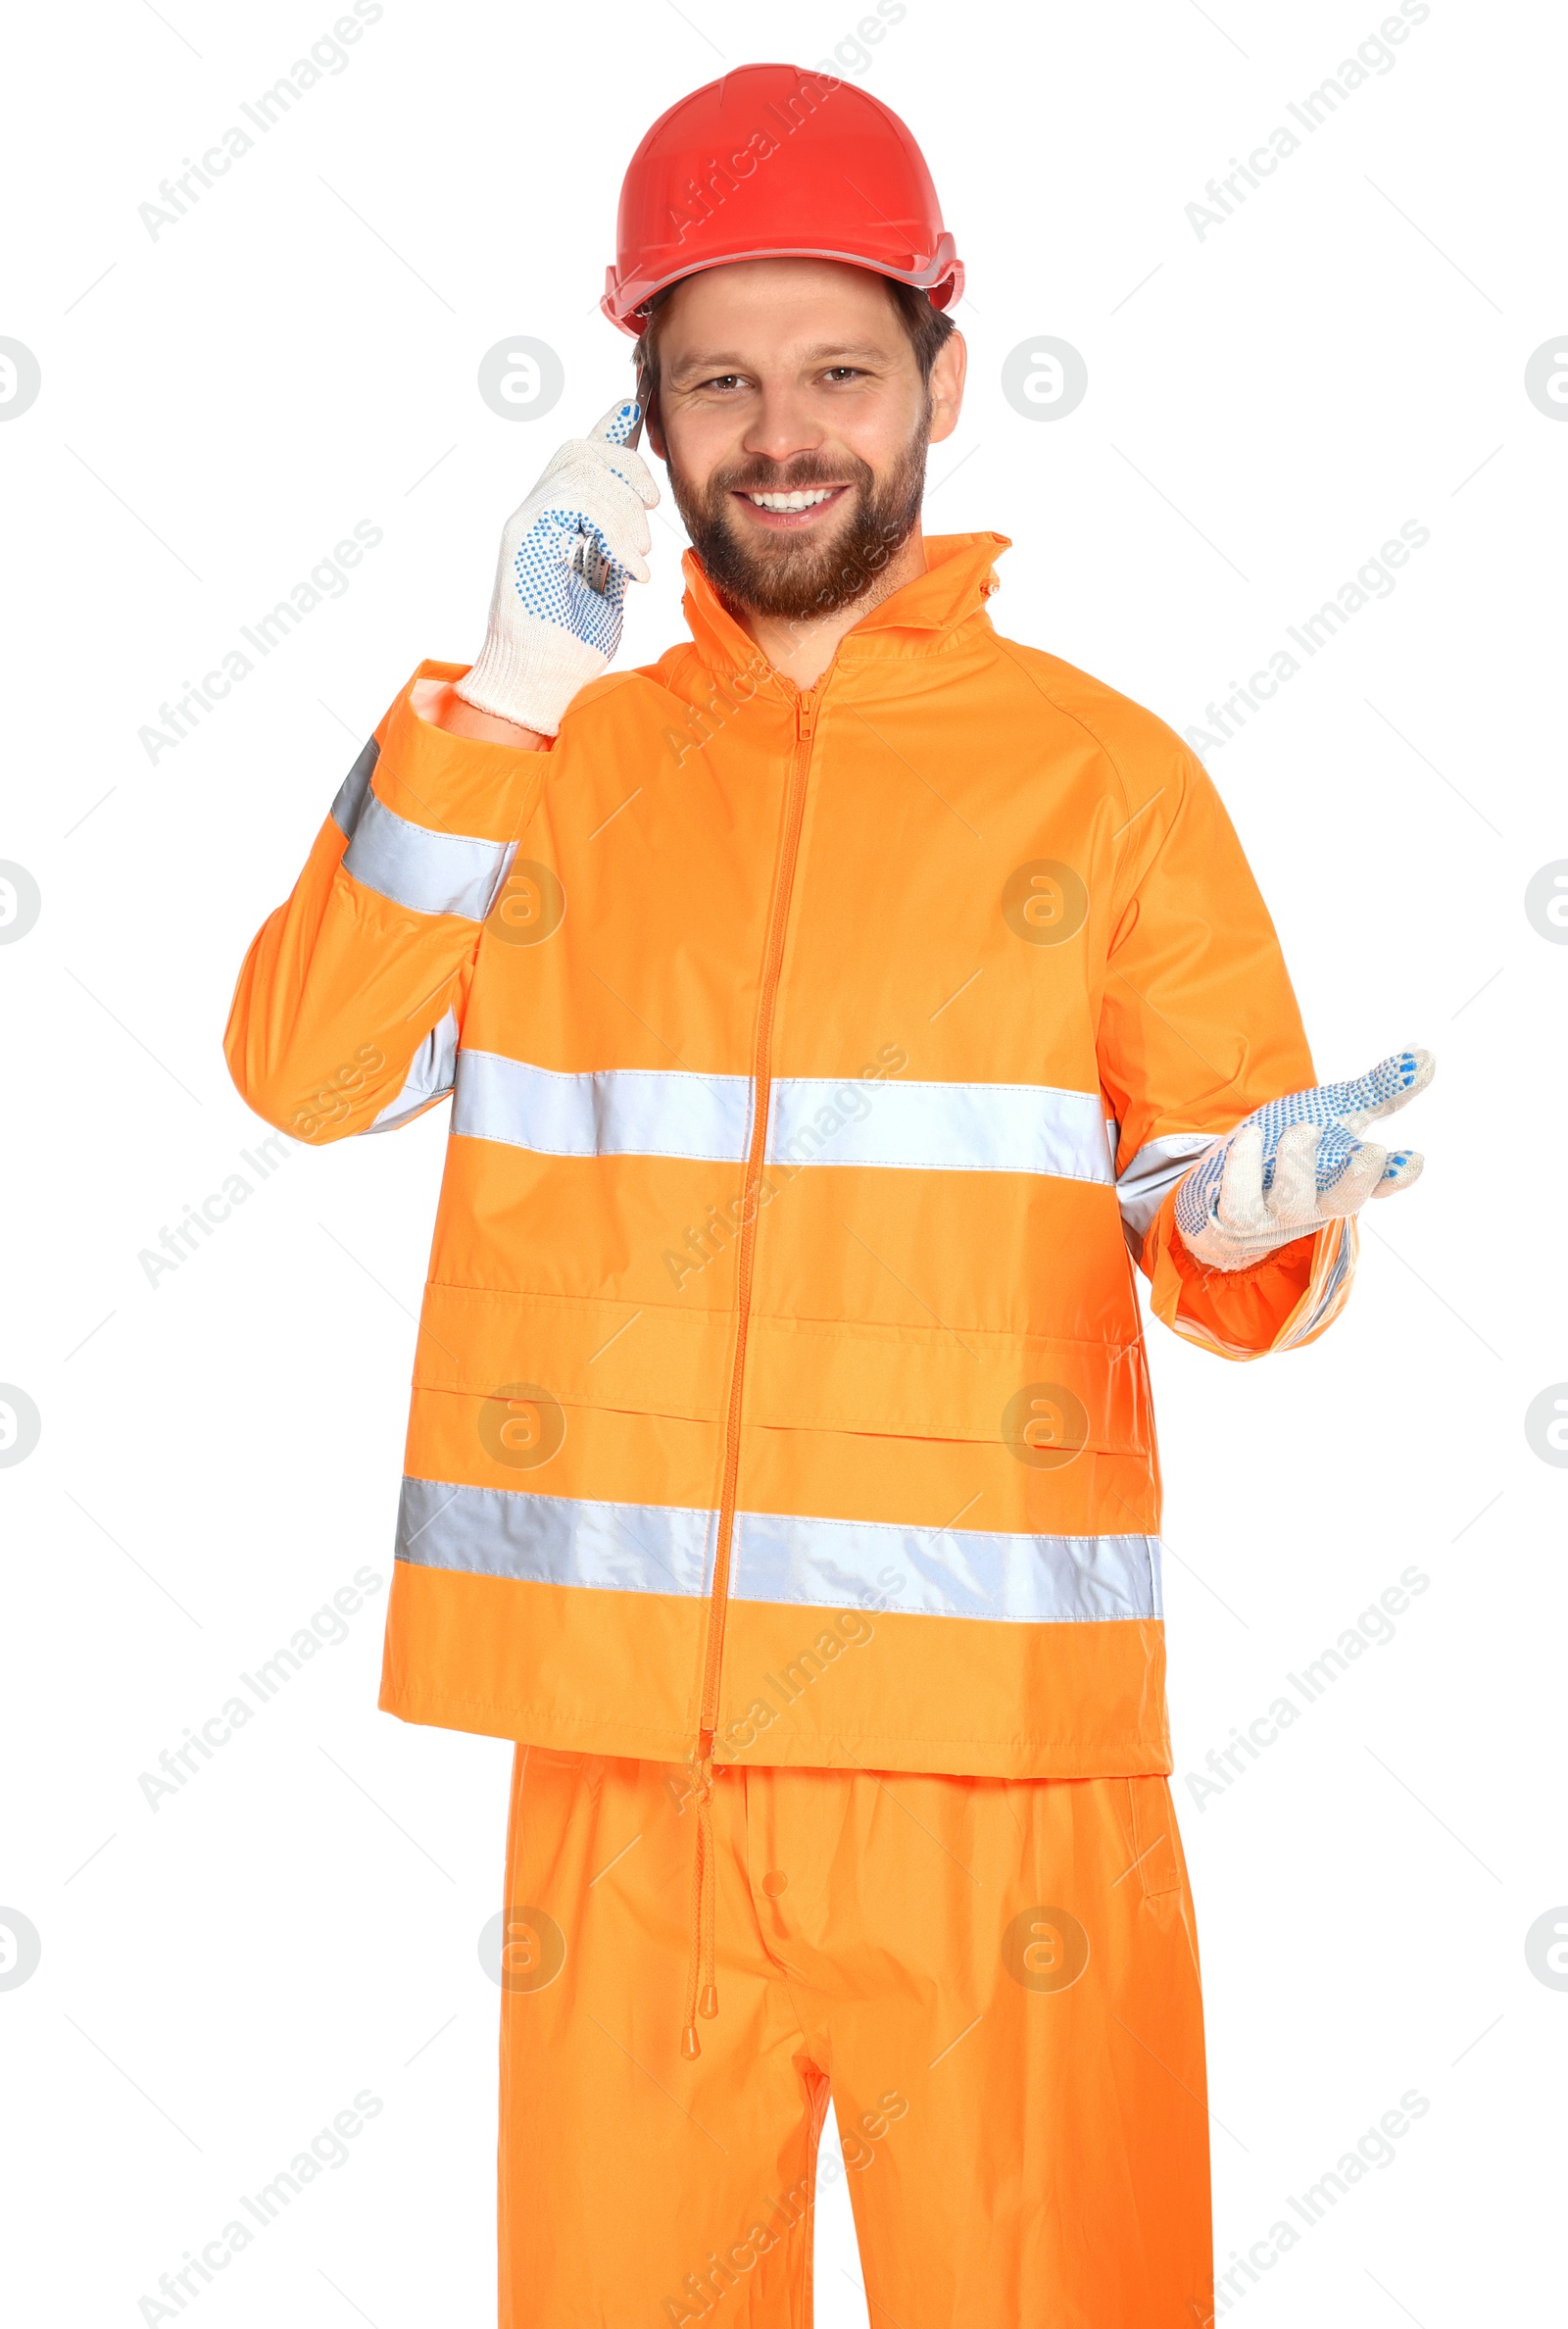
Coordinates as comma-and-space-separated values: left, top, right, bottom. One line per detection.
697, 687, 817, 1759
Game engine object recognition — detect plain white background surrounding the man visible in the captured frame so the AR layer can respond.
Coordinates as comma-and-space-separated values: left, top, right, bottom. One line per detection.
0, 0, 1568, 2329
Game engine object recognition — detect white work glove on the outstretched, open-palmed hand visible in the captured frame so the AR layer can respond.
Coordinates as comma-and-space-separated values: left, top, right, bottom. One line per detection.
1177, 1051, 1438, 1269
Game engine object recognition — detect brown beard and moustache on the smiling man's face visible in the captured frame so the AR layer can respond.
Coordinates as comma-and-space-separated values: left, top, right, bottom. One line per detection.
668, 408, 930, 621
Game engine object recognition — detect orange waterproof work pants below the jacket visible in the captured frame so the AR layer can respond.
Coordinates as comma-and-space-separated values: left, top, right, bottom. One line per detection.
501, 1747, 1211, 2329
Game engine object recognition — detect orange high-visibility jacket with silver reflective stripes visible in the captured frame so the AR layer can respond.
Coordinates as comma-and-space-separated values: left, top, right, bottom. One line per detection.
228, 533, 1353, 1777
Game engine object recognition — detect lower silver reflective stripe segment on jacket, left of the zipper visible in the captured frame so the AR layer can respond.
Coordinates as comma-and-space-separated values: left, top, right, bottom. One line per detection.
396, 1479, 717, 1596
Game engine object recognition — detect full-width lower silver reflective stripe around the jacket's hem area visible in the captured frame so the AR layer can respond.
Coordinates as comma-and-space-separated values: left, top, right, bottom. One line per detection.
399, 1479, 1162, 1625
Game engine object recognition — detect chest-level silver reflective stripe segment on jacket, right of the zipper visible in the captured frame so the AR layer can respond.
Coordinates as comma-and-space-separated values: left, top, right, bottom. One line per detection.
766, 1076, 1116, 1181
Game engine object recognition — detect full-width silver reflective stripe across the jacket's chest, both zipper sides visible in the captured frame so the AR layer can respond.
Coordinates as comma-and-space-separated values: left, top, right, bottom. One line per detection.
452, 1066, 1113, 1183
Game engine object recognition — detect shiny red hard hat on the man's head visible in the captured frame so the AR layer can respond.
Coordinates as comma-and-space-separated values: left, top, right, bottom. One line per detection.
599, 66, 964, 335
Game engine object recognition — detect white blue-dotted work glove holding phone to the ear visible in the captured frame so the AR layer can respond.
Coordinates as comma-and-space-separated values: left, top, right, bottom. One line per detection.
457, 401, 660, 736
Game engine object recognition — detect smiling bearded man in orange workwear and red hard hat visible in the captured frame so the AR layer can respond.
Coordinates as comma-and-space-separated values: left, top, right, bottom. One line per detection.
228, 66, 1431, 2329
